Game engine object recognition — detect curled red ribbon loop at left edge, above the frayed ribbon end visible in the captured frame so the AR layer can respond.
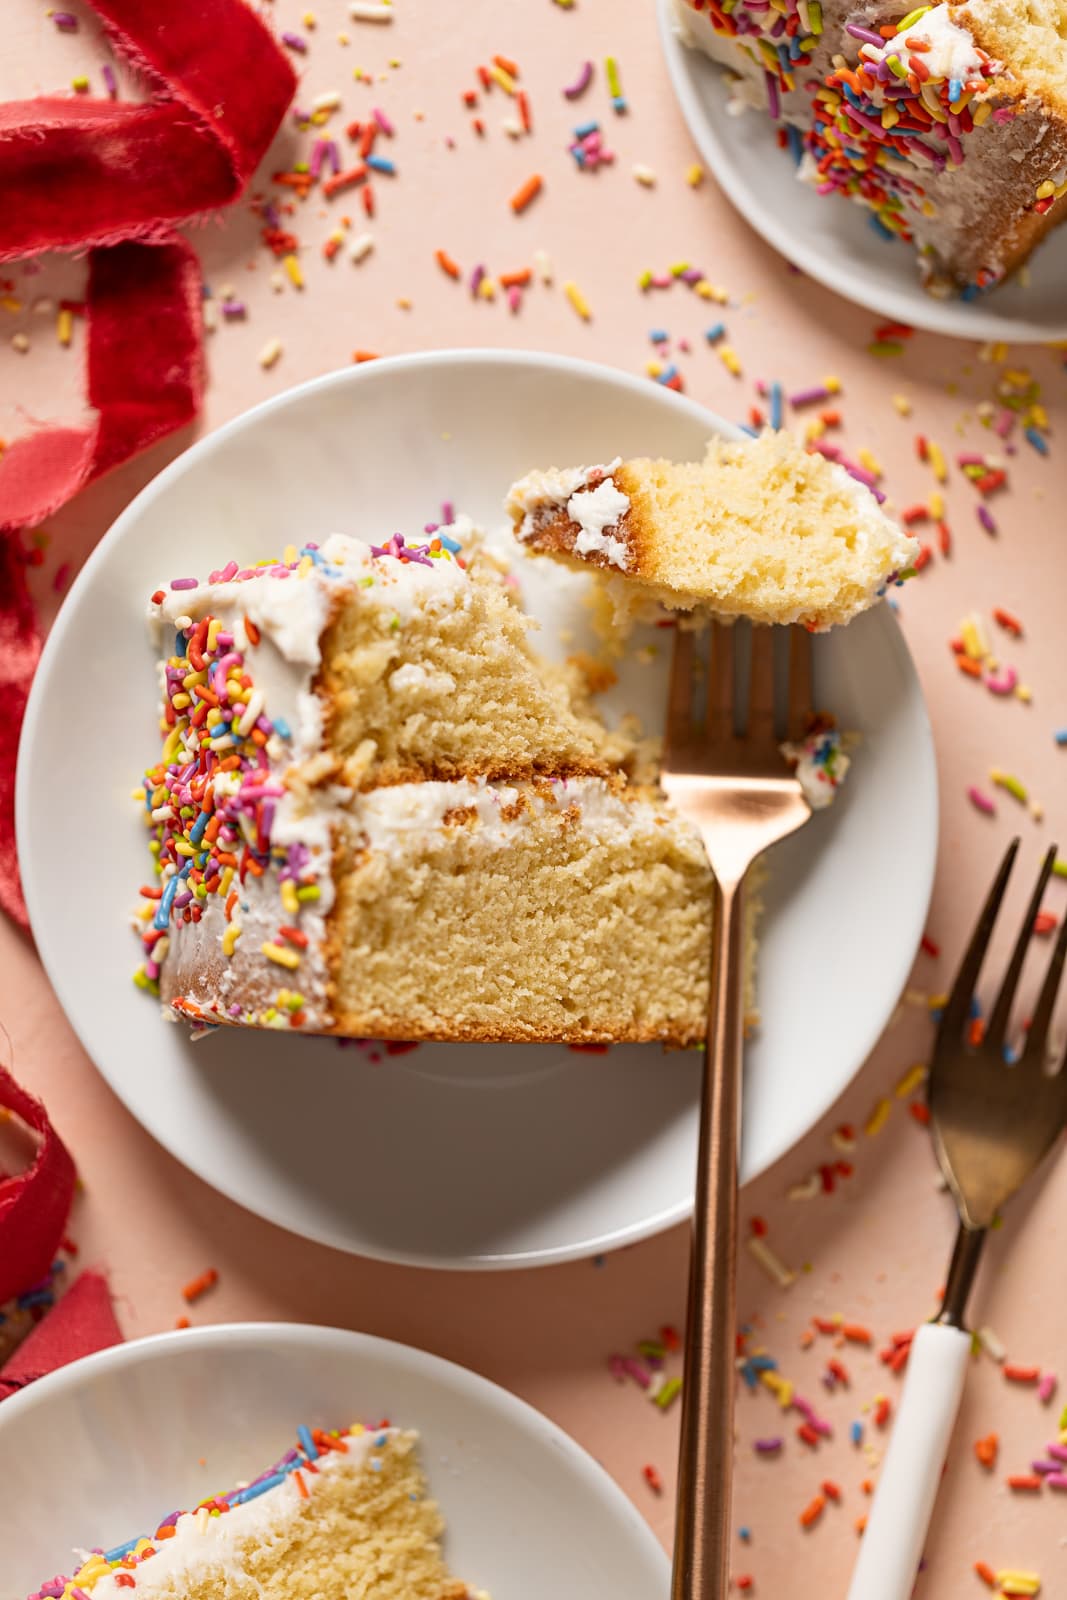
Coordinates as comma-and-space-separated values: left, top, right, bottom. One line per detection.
0, 1067, 74, 1306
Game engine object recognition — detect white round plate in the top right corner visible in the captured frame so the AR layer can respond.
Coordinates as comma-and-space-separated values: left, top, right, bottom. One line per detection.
659, 0, 1067, 344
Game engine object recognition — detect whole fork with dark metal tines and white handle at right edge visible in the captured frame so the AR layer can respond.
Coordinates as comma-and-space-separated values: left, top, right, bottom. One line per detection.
848, 838, 1067, 1600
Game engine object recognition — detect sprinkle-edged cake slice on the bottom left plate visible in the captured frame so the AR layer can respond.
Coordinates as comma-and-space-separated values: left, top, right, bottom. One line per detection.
29, 1424, 470, 1600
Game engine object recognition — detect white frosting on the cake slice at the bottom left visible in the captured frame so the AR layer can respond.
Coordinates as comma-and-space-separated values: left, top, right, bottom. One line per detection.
81, 1429, 391, 1600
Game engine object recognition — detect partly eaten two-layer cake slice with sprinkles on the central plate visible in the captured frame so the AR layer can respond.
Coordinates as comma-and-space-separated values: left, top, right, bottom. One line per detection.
136, 530, 712, 1045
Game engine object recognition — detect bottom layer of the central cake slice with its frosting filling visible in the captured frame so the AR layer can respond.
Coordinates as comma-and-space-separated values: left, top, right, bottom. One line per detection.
162, 778, 712, 1045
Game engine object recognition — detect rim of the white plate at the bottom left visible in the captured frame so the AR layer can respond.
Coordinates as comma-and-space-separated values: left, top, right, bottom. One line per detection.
0, 1320, 670, 1594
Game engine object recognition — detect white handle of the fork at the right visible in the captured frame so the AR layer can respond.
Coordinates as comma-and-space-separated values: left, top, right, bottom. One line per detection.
848, 1322, 971, 1600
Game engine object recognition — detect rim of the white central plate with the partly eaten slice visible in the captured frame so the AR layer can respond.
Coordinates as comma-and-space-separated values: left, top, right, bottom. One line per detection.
14, 346, 939, 1272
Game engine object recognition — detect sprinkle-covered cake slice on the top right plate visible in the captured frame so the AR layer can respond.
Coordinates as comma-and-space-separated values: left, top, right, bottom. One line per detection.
673, 0, 1067, 298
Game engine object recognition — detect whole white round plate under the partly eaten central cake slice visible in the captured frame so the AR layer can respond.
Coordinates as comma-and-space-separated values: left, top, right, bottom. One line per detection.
18, 350, 937, 1267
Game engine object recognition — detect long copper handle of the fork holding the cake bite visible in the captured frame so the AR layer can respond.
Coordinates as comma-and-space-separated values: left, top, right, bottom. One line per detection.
670, 882, 744, 1600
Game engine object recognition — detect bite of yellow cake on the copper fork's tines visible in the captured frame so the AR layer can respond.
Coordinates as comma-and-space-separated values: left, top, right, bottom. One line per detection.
507, 432, 918, 629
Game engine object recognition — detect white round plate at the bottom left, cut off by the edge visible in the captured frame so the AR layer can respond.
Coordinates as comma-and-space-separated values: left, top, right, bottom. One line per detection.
0, 1323, 670, 1600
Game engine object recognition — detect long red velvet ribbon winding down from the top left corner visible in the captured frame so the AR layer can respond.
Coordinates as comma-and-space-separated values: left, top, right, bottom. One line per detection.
0, 0, 296, 925
